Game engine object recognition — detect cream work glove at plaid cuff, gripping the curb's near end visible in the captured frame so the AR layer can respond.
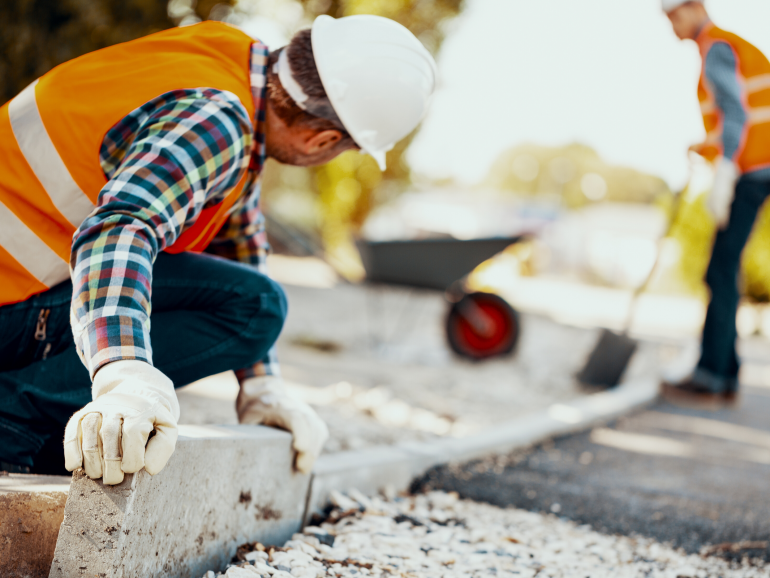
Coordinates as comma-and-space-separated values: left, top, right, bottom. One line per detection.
64, 360, 179, 484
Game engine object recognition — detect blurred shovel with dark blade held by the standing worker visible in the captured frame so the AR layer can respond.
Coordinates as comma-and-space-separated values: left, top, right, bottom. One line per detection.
575, 188, 687, 389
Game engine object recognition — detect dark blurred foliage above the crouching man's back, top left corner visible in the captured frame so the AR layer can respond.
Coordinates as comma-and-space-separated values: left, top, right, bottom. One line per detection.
0, 0, 235, 103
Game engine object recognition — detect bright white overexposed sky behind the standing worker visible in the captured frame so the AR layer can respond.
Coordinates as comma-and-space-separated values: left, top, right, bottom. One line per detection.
402, 0, 770, 188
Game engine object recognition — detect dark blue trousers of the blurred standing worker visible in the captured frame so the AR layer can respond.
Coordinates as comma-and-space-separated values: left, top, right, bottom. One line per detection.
696, 177, 770, 392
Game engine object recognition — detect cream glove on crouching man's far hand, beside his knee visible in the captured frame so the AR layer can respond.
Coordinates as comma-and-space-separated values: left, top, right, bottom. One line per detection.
235, 375, 329, 474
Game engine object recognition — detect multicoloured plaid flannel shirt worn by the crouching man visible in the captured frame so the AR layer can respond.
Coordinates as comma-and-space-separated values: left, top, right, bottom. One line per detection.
70, 42, 278, 379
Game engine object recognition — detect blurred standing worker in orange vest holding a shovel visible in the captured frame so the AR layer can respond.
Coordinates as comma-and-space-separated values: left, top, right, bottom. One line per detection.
663, 0, 770, 403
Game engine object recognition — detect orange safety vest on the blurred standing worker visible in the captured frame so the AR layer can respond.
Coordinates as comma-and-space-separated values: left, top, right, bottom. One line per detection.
696, 23, 770, 173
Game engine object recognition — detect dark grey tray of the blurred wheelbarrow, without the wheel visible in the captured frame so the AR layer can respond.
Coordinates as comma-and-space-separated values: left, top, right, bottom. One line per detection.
356, 235, 522, 291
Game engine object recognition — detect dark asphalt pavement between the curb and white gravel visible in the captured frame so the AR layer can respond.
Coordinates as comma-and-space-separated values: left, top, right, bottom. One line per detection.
413, 387, 770, 560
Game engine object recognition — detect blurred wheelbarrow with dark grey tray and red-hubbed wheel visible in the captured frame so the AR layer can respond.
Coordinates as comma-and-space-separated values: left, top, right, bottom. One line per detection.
356, 236, 524, 360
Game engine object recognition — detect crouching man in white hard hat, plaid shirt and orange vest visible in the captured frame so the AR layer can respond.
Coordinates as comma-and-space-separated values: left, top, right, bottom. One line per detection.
0, 16, 436, 484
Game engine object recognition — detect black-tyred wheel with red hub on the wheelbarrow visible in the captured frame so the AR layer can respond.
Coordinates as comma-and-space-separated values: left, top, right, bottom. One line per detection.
446, 293, 519, 360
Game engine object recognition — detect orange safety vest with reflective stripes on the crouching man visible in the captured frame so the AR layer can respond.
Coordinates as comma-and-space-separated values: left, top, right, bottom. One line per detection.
0, 22, 255, 305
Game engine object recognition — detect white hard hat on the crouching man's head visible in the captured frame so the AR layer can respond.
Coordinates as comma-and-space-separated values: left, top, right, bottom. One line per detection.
311, 14, 436, 170
